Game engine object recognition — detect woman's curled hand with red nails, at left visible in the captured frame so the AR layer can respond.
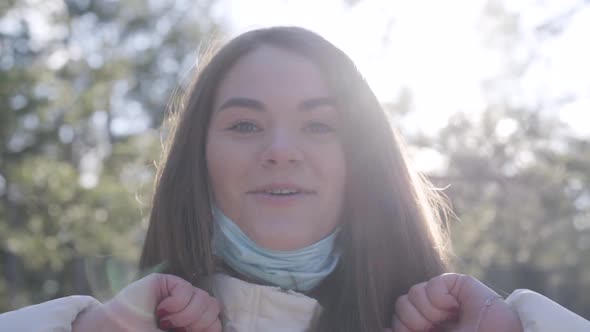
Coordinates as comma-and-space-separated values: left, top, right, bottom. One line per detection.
72, 274, 221, 332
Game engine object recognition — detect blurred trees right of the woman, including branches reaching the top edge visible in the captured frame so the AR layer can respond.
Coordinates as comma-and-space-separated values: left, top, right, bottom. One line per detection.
393, 0, 590, 318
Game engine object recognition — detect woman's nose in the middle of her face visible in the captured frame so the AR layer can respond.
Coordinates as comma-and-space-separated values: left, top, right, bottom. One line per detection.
262, 130, 303, 167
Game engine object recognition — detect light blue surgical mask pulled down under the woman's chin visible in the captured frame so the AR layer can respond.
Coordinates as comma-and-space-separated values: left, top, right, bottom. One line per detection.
212, 207, 340, 292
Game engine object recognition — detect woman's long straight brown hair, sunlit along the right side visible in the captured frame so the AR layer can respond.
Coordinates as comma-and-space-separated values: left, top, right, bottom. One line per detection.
140, 27, 448, 332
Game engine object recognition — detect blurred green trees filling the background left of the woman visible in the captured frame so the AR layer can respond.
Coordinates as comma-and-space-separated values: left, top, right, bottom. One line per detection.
0, 0, 224, 311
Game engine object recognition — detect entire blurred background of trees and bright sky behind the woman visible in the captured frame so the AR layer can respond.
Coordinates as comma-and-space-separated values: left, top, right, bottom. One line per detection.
0, 0, 590, 319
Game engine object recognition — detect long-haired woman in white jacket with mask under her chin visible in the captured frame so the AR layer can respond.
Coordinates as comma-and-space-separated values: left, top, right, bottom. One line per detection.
0, 27, 589, 332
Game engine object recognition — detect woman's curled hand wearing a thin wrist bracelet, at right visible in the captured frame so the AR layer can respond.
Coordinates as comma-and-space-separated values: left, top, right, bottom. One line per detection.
392, 273, 522, 332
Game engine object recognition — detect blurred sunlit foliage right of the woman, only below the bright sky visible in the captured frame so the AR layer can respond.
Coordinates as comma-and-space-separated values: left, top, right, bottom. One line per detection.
415, 109, 590, 317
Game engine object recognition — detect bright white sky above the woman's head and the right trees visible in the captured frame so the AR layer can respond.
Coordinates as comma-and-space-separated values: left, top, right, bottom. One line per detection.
219, 0, 590, 137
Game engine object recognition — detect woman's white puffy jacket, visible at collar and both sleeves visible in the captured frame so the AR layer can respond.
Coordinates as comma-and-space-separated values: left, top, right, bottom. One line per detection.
0, 274, 590, 332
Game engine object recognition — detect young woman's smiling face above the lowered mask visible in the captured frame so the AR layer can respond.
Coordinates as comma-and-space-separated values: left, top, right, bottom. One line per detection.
206, 46, 346, 250
